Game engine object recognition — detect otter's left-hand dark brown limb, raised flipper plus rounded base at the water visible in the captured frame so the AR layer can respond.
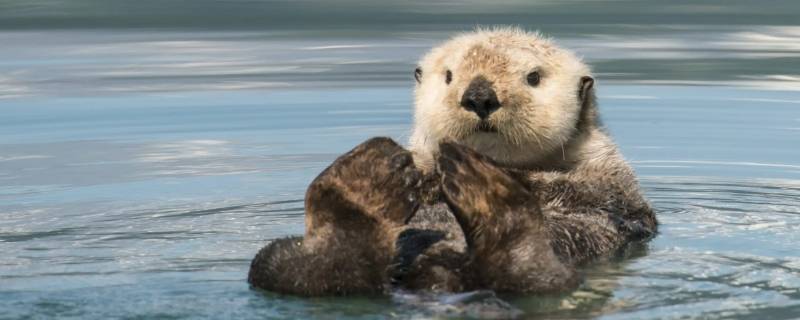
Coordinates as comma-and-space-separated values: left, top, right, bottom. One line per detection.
248, 138, 421, 296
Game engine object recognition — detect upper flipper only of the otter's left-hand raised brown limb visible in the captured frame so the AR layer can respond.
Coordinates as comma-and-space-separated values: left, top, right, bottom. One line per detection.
306, 138, 422, 228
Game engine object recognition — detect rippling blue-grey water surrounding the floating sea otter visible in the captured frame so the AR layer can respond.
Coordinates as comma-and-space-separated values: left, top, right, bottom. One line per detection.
0, 0, 800, 319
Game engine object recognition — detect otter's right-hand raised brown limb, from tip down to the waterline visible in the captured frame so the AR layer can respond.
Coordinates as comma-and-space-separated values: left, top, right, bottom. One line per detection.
437, 143, 578, 293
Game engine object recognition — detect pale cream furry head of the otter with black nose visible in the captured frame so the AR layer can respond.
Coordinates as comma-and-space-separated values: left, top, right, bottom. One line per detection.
410, 29, 595, 169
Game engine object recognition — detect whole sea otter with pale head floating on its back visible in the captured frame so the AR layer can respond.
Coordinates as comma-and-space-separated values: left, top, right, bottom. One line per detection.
248, 28, 657, 296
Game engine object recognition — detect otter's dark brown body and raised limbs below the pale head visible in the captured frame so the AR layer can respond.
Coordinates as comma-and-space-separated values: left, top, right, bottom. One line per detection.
248, 138, 655, 296
